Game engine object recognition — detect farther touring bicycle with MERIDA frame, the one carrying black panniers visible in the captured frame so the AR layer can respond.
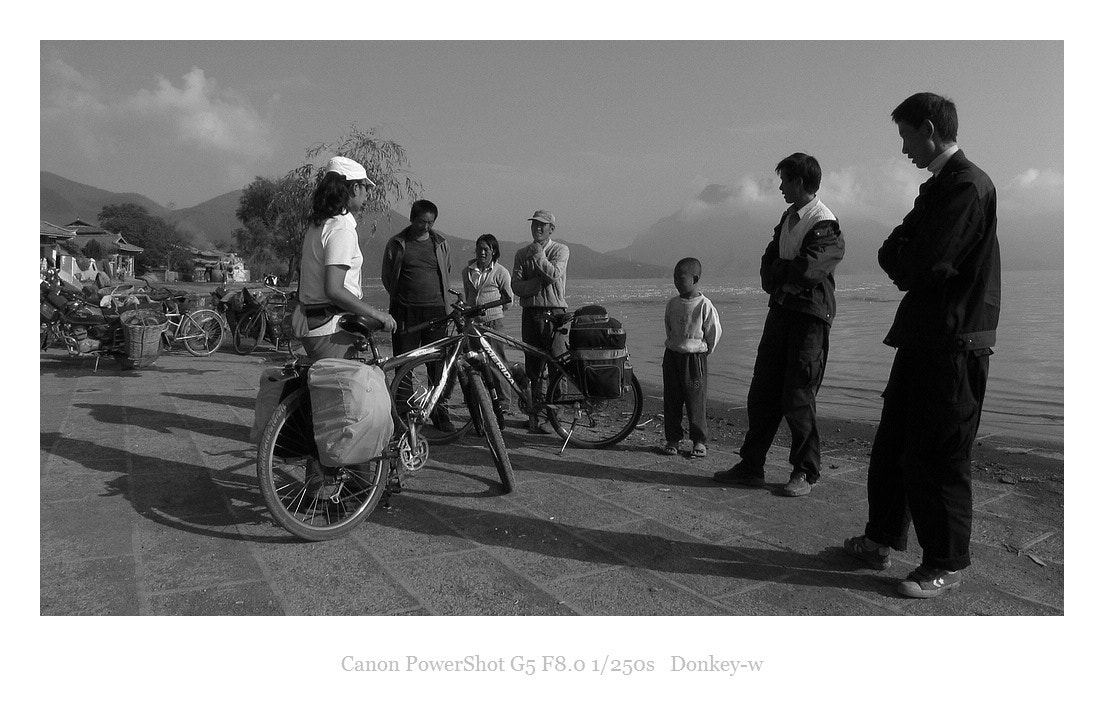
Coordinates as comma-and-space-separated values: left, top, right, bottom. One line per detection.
391, 291, 644, 445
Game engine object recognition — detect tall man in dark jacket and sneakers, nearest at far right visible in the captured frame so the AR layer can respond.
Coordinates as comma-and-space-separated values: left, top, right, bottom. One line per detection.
843, 93, 1000, 598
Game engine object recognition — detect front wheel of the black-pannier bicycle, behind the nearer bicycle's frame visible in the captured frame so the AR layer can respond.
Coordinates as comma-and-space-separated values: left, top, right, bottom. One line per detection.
390, 354, 471, 445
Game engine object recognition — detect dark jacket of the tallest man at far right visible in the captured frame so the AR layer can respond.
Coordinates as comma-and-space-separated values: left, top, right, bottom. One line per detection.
878, 151, 1000, 351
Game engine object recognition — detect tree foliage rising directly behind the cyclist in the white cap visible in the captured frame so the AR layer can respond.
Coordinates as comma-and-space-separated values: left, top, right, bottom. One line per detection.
234, 125, 422, 281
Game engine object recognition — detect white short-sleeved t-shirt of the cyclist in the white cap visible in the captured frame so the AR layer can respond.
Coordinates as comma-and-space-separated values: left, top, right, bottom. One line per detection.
299, 212, 364, 336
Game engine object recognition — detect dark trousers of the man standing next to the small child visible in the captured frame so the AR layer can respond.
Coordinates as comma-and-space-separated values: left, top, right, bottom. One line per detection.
740, 306, 829, 482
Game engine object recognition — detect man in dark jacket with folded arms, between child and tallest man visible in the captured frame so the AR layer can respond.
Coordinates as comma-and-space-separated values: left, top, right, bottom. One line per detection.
713, 153, 843, 498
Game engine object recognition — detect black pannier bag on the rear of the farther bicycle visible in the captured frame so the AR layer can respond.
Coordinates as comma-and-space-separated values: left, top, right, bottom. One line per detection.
567, 306, 631, 398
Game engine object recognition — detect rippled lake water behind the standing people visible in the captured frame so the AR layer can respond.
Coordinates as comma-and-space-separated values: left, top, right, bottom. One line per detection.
365, 270, 1064, 448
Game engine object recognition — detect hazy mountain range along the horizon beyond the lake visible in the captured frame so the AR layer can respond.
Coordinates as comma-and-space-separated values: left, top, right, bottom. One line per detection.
40, 171, 1063, 281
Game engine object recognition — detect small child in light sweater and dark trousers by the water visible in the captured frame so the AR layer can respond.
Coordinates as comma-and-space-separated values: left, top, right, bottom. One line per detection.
664, 257, 721, 458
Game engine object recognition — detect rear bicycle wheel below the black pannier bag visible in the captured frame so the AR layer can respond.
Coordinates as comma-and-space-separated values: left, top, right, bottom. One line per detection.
546, 372, 644, 448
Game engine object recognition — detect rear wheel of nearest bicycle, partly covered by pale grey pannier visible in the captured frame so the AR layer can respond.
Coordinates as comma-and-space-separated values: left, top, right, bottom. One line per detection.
257, 388, 386, 542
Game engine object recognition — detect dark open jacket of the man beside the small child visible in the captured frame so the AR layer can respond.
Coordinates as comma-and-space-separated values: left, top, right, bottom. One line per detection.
760, 214, 843, 325
